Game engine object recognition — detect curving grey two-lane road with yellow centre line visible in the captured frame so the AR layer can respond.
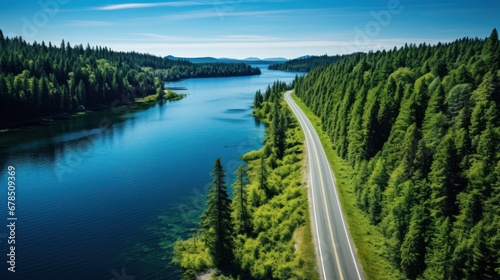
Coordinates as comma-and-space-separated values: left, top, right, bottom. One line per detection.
285, 91, 363, 280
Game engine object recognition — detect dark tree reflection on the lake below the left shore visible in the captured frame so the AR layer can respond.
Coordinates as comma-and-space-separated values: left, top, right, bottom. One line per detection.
0, 109, 133, 172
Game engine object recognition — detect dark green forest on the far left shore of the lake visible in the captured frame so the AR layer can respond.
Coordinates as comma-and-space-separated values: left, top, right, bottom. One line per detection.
0, 30, 260, 125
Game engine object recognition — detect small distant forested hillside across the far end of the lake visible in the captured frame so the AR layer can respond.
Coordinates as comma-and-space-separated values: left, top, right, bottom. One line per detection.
268, 54, 346, 72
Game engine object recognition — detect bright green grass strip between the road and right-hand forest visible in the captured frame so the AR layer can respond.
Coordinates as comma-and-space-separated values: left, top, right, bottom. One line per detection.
292, 94, 405, 279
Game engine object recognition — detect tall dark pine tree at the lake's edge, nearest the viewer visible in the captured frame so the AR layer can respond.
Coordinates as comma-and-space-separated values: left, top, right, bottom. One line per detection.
201, 158, 233, 270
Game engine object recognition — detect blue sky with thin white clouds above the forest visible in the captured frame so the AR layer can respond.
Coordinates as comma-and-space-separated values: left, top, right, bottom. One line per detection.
0, 0, 500, 58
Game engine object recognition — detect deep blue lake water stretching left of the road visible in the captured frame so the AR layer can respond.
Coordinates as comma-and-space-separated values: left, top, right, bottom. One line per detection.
0, 66, 300, 280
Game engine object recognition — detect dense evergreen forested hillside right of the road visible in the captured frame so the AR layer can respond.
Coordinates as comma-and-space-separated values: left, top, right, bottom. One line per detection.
296, 30, 500, 279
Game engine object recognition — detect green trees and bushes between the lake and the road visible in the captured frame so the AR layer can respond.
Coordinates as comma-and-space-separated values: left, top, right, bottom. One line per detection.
173, 82, 319, 280
